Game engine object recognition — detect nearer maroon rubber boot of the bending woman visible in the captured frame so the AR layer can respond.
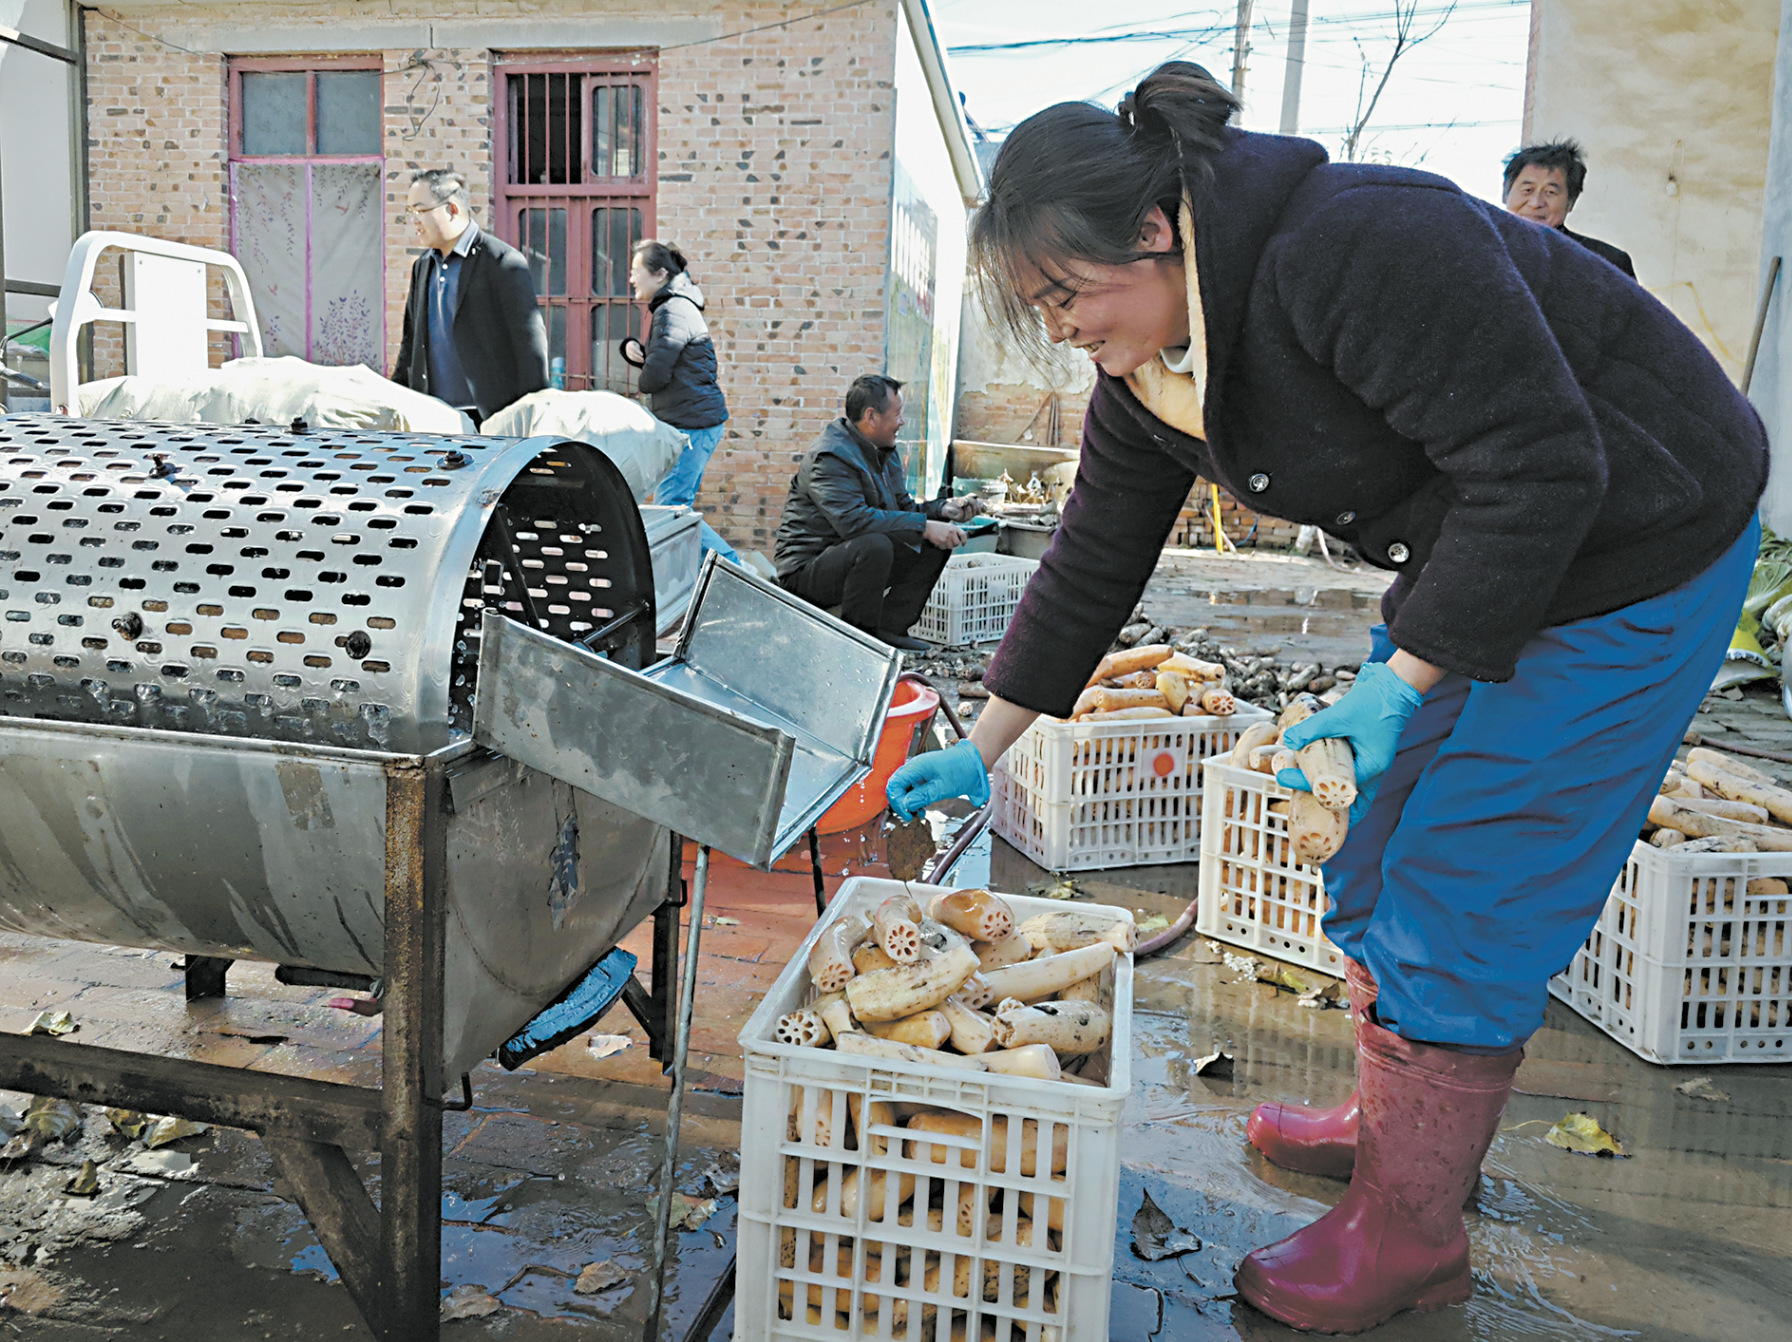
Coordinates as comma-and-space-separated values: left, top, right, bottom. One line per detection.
1233, 1019, 1525, 1333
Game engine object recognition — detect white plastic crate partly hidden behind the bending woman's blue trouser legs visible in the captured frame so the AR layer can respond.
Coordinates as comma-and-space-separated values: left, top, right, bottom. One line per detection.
1195, 756, 1344, 975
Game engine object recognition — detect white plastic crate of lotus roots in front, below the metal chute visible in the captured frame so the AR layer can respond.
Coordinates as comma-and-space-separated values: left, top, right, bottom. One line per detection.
735, 876, 1133, 1342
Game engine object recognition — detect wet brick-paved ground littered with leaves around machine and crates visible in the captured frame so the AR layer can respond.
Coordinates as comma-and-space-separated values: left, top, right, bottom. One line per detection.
0, 548, 1792, 1342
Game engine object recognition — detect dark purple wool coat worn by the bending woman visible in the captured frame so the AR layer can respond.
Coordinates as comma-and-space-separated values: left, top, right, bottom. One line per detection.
984, 131, 1767, 717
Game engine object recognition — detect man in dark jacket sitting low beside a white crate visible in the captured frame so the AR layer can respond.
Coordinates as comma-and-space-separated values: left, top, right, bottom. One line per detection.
776, 373, 977, 652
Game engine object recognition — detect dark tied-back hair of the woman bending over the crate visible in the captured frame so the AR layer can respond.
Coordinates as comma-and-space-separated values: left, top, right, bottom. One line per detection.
971, 61, 1240, 349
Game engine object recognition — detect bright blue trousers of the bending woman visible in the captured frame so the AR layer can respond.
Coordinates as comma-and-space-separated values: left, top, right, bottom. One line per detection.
1324, 523, 1762, 1052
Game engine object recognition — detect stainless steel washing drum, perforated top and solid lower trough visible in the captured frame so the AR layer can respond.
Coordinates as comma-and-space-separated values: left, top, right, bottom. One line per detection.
0, 416, 670, 1075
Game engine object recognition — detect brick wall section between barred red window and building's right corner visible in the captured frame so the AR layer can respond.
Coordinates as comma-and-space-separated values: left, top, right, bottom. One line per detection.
659, 0, 898, 554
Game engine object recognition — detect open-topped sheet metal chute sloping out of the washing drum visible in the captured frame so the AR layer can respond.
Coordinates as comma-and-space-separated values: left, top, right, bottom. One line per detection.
473, 555, 900, 867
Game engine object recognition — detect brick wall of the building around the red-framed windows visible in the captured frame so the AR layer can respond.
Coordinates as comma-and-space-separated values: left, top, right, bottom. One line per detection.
86, 0, 898, 552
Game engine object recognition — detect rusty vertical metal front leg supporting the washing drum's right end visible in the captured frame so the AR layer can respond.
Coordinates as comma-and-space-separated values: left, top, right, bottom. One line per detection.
380, 767, 448, 1342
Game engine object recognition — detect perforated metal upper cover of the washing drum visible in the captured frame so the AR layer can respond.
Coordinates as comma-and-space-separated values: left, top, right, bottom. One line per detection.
0, 416, 654, 753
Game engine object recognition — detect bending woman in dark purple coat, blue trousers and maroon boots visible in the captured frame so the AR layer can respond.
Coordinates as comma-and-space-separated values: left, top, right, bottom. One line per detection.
889, 63, 1767, 1333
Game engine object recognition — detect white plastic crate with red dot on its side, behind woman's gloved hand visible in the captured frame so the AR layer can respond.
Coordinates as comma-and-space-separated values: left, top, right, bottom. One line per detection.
993, 704, 1269, 871
